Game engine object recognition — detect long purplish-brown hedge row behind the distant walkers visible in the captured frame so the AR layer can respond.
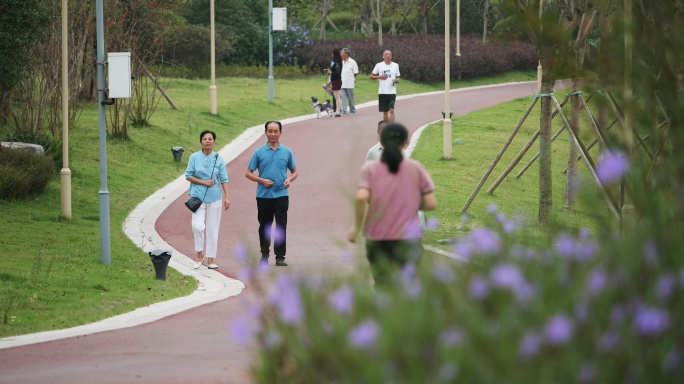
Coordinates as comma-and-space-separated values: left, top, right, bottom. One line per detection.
294, 35, 538, 82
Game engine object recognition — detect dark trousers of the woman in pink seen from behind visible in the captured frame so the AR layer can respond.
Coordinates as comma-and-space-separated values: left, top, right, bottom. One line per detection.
366, 239, 423, 286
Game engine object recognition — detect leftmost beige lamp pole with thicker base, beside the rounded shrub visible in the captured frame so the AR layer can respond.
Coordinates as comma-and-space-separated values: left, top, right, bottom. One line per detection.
60, 0, 71, 219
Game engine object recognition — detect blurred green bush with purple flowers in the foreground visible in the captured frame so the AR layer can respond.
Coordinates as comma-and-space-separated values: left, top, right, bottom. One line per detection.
242, 196, 684, 383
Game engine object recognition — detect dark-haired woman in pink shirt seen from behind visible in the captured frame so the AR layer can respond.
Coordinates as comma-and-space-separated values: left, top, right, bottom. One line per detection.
347, 123, 437, 286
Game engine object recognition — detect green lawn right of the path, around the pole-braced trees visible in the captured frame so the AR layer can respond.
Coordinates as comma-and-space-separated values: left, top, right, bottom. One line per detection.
411, 94, 612, 249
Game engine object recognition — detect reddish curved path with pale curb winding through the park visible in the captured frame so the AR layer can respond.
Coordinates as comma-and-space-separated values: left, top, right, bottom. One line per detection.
0, 82, 560, 383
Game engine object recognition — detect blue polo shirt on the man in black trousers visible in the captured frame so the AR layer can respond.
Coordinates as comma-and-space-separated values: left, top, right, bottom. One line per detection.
247, 143, 297, 199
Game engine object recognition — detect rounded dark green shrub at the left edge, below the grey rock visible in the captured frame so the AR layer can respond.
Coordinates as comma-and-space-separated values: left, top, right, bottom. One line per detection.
0, 148, 55, 200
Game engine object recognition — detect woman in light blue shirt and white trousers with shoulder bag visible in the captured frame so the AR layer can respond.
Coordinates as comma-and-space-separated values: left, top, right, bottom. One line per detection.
185, 130, 230, 269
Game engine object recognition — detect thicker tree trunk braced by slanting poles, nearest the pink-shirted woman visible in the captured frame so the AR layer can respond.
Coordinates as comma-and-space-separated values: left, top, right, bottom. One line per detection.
538, 76, 555, 227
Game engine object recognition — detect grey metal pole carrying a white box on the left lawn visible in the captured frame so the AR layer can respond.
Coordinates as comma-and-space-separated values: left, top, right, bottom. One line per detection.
95, 0, 112, 264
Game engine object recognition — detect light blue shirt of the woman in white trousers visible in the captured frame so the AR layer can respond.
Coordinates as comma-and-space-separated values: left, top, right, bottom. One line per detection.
185, 151, 228, 203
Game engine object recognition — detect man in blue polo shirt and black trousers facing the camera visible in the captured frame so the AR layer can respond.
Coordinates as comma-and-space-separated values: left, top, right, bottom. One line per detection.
245, 121, 297, 267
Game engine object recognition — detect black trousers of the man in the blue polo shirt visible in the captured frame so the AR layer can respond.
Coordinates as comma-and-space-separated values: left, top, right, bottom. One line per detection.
257, 196, 290, 260
